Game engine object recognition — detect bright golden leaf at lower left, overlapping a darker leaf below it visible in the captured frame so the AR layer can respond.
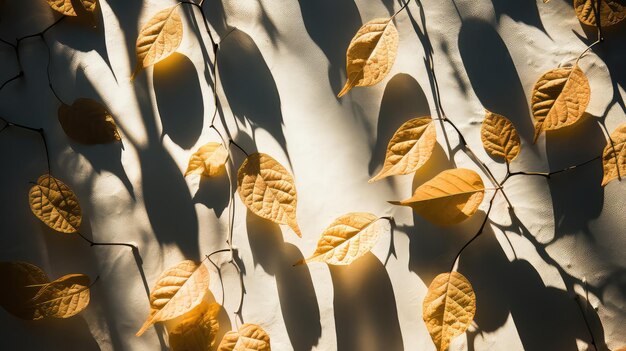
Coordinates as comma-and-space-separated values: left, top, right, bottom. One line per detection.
137, 260, 209, 336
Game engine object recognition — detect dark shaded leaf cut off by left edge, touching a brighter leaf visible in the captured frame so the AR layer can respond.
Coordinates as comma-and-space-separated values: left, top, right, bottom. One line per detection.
0, 262, 49, 319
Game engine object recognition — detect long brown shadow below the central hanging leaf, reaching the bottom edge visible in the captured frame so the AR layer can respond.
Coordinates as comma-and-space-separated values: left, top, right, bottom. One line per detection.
246, 211, 320, 351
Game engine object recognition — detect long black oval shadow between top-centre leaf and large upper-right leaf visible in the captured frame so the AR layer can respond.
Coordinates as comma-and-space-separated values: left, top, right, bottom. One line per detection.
459, 18, 534, 141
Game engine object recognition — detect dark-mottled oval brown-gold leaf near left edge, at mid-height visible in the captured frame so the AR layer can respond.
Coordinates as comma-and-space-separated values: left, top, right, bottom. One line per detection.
28, 174, 83, 234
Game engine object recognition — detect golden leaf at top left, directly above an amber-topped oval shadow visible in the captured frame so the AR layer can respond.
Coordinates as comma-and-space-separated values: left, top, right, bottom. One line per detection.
131, 5, 183, 79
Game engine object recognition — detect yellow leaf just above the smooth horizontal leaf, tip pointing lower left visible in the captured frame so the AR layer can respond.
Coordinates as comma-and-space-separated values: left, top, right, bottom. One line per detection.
369, 117, 437, 183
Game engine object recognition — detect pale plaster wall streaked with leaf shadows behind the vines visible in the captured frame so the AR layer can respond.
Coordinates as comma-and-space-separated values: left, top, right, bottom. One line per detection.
0, 0, 626, 351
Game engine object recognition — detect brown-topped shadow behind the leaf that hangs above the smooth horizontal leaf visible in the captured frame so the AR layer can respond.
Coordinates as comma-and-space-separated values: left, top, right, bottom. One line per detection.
369, 73, 430, 175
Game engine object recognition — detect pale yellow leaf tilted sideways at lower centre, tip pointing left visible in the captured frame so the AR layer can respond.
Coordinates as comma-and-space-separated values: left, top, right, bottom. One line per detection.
296, 212, 389, 265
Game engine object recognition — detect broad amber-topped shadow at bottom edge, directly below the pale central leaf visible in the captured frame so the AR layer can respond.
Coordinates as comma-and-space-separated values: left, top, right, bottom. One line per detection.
329, 253, 404, 351
